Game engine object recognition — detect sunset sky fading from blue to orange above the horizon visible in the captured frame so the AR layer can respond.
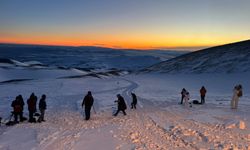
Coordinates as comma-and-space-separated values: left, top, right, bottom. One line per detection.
0, 0, 250, 49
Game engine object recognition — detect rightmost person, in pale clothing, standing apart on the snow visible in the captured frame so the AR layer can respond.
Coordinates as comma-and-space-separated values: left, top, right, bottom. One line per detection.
231, 84, 243, 109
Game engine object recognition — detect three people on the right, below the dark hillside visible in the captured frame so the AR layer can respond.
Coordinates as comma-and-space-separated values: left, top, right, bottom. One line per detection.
180, 84, 243, 109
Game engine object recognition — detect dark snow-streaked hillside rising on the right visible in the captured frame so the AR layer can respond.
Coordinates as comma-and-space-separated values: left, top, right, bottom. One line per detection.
142, 40, 250, 74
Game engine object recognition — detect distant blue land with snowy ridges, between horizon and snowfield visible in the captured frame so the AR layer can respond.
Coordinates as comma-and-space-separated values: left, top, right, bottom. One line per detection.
0, 44, 184, 83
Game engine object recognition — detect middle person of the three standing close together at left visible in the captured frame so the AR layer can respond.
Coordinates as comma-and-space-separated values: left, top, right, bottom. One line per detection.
27, 93, 37, 123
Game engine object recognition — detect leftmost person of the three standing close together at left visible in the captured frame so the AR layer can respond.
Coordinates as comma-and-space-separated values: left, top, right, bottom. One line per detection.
11, 96, 24, 123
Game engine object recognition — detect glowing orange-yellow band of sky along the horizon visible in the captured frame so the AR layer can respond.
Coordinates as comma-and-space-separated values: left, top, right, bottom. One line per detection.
0, 36, 248, 50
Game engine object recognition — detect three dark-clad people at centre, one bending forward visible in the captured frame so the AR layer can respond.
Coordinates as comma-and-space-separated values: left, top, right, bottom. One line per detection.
82, 91, 137, 120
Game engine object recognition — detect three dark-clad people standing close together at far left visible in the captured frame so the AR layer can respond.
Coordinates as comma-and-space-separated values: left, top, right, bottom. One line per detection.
11, 93, 47, 123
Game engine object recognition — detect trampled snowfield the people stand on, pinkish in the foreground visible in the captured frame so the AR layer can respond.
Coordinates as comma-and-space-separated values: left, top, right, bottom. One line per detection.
0, 71, 250, 150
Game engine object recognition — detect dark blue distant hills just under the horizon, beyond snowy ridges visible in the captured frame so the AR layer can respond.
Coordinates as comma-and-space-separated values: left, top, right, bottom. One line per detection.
0, 44, 185, 72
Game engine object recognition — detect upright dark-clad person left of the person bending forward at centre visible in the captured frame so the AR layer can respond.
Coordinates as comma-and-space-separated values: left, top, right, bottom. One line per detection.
82, 91, 94, 120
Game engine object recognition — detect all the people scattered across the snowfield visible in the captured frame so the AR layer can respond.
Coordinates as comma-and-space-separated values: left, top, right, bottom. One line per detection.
0, 84, 243, 123
